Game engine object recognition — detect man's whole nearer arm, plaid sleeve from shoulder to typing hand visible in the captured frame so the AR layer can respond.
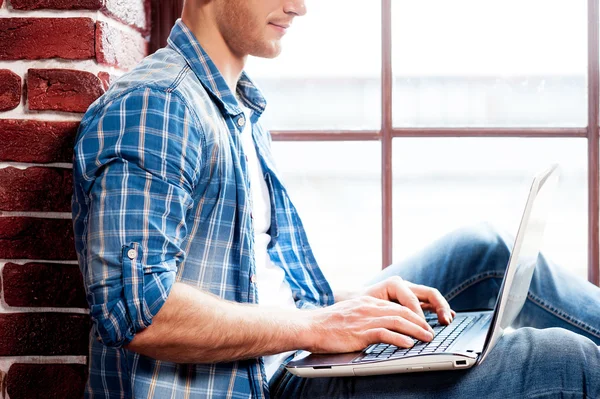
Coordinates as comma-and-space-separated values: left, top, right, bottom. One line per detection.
74, 89, 431, 363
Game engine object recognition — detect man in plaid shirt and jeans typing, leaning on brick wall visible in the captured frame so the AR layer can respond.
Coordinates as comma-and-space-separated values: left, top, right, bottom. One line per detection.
73, 0, 600, 398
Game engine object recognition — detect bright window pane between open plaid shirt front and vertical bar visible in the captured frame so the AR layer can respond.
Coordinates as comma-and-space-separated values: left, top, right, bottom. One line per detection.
273, 142, 382, 287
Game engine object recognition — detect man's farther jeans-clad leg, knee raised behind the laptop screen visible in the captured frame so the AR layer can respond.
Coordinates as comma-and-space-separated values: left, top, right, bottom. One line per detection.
373, 224, 600, 345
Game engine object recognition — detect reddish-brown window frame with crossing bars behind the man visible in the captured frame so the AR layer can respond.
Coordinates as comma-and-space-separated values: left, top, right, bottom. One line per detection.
150, 0, 600, 286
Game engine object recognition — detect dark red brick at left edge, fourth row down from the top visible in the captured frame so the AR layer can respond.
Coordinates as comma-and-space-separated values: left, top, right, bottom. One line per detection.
0, 119, 79, 163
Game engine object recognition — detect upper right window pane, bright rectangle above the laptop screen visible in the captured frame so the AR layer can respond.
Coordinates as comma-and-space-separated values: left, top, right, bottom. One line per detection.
392, 0, 587, 127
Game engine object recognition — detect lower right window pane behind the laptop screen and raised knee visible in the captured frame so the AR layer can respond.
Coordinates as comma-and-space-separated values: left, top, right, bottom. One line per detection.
393, 138, 588, 278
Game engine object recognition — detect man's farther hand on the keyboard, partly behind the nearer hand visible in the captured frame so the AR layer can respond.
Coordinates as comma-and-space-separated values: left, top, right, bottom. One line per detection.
362, 276, 456, 324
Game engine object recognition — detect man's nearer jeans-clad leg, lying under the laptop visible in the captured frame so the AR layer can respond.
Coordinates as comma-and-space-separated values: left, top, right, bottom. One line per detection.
271, 328, 600, 399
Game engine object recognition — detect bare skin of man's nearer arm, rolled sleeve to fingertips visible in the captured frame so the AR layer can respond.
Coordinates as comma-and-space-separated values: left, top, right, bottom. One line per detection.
126, 283, 432, 363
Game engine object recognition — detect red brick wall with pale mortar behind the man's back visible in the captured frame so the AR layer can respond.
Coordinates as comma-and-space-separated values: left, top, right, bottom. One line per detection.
0, 0, 150, 399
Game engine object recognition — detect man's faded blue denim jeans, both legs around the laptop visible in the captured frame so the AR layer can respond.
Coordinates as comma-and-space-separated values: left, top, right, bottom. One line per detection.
271, 224, 600, 399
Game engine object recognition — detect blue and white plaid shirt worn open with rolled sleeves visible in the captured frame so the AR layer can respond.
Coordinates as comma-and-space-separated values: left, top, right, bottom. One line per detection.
72, 20, 333, 398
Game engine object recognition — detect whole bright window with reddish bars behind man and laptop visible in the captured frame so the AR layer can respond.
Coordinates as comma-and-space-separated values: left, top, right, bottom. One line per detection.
153, 0, 600, 285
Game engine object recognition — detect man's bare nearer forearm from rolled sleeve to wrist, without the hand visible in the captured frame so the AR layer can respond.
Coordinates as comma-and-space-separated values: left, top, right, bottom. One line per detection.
126, 283, 309, 363
